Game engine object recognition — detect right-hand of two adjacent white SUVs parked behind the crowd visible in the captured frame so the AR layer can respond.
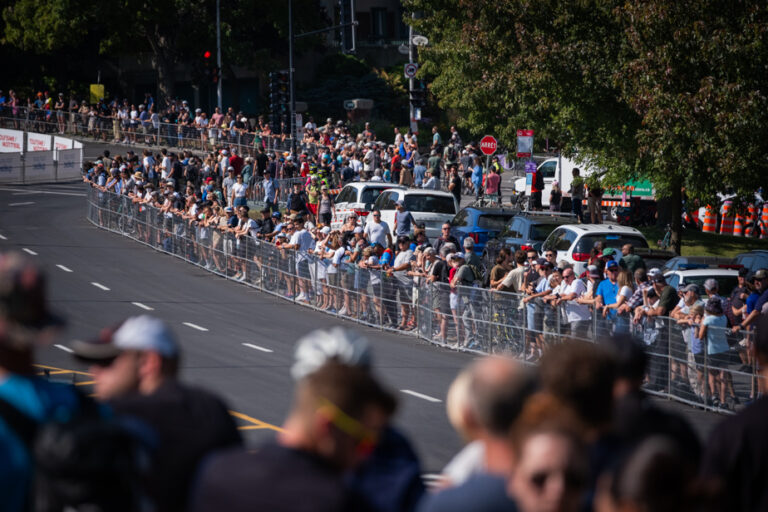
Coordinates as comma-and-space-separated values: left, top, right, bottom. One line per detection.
373, 188, 459, 239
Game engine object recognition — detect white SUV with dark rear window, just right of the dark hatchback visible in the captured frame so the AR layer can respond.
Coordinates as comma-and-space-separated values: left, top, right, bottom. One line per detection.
542, 224, 648, 275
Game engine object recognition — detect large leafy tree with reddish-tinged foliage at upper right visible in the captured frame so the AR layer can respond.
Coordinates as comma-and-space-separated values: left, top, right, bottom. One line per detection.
406, 0, 768, 252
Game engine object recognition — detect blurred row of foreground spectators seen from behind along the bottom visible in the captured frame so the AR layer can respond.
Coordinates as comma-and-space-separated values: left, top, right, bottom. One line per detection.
0, 253, 768, 512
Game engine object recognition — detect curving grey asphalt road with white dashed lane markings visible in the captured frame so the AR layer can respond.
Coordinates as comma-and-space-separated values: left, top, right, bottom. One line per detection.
0, 169, 721, 472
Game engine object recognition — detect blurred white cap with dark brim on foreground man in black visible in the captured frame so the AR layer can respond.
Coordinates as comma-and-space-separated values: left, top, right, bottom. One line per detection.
72, 315, 179, 361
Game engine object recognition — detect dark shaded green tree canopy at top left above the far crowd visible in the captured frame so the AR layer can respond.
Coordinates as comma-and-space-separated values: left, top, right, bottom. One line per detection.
0, 0, 327, 104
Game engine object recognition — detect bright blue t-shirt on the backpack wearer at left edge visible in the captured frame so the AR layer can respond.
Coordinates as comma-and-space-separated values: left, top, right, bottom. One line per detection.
0, 374, 84, 512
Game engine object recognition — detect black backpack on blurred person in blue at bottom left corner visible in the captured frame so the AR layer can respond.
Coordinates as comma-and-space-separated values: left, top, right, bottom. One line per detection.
0, 393, 149, 512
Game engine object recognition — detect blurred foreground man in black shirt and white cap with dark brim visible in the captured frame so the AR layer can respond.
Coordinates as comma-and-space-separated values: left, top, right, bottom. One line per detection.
72, 315, 241, 511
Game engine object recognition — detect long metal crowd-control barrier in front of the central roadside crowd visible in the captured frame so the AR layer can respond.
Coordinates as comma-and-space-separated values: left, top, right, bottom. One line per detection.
88, 187, 765, 413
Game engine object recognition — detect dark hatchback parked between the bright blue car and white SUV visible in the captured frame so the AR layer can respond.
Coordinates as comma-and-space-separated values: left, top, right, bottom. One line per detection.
483, 212, 574, 268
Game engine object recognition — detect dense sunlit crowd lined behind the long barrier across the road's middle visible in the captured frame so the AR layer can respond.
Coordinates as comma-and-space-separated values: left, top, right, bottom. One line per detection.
84, 142, 765, 409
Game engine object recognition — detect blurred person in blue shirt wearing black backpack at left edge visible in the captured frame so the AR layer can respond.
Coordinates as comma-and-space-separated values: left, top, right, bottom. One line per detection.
0, 253, 150, 512
